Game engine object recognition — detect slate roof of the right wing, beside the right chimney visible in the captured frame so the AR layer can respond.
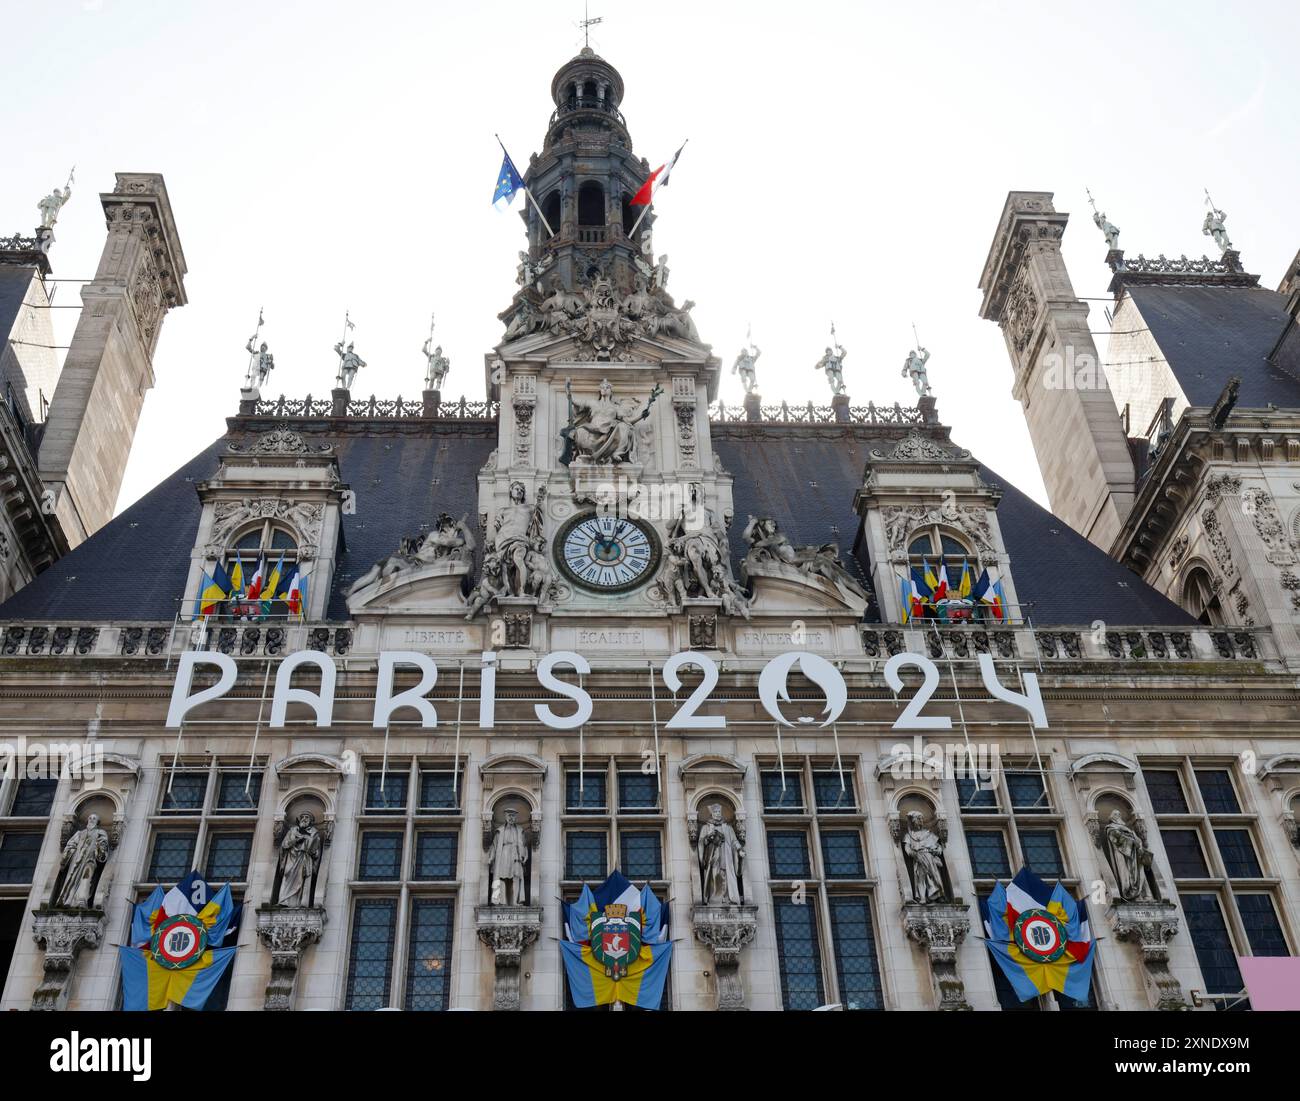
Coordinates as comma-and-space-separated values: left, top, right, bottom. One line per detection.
1128, 286, 1300, 408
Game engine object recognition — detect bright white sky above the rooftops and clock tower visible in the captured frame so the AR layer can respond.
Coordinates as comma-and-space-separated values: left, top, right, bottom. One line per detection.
0, 0, 1300, 508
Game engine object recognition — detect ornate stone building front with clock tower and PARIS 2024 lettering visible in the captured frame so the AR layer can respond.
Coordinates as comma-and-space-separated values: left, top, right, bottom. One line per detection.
0, 51, 1300, 1011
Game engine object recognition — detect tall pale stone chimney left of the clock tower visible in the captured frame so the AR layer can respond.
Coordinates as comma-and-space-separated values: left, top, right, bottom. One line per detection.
39, 172, 186, 546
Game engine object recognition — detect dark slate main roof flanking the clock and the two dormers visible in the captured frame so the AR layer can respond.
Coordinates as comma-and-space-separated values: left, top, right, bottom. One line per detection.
0, 421, 1192, 627
